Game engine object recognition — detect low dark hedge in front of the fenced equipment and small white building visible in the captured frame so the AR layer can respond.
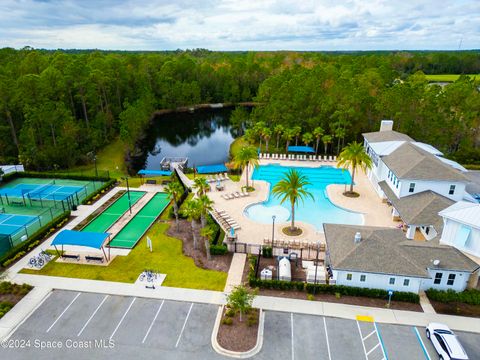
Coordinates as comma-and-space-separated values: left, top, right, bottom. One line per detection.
248, 256, 420, 304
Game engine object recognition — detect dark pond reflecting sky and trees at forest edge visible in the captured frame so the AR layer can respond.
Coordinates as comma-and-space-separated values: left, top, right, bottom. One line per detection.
132, 109, 236, 171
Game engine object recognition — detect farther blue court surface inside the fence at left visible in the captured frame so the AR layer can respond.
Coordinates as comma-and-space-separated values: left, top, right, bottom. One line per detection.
0, 183, 85, 200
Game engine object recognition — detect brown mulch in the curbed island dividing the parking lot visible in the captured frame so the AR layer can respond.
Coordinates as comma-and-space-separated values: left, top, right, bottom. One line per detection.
217, 309, 260, 352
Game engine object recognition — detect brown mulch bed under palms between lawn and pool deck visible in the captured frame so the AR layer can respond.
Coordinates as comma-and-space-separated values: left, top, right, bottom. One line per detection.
167, 219, 233, 272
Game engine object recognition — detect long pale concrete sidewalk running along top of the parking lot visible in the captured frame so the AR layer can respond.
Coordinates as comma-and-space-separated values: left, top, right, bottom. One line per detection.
7, 274, 480, 333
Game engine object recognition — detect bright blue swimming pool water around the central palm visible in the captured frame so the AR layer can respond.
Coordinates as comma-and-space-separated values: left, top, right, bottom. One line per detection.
245, 164, 363, 232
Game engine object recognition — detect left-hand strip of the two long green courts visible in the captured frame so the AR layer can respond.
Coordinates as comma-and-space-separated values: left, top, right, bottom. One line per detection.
82, 191, 145, 232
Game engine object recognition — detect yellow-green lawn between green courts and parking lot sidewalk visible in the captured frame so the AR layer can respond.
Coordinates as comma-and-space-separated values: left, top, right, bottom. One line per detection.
21, 223, 227, 291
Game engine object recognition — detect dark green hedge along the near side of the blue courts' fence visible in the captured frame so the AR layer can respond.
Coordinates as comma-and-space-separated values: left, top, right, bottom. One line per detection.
0, 211, 70, 267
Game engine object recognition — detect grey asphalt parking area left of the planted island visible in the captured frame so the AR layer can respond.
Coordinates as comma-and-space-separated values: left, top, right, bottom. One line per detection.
0, 291, 221, 360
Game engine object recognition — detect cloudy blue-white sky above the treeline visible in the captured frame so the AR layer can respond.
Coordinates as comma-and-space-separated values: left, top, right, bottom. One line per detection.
0, 0, 480, 51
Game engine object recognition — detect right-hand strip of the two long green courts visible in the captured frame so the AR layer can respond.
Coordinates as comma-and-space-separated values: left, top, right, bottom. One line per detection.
110, 193, 170, 249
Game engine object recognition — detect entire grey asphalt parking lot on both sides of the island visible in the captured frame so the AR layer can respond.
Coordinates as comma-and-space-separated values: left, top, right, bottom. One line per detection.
0, 291, 480, 360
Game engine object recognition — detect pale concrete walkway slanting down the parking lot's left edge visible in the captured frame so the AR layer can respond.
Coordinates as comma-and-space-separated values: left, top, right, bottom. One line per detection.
0, 287, 52, 341
